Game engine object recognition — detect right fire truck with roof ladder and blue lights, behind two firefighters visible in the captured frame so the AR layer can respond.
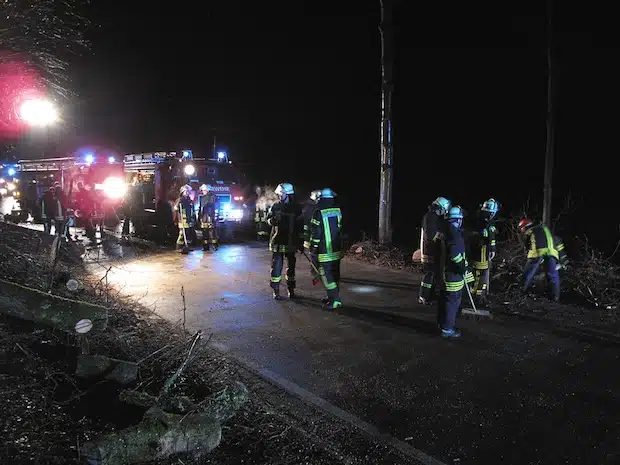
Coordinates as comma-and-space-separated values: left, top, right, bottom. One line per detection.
124, 150, 251, 238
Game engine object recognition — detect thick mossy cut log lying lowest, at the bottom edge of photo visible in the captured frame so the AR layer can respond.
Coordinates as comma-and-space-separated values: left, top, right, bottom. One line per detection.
81, 407, 222, 465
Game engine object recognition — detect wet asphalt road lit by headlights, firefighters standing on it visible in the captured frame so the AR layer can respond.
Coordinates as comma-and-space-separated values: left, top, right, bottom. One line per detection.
91, 243, 620, 465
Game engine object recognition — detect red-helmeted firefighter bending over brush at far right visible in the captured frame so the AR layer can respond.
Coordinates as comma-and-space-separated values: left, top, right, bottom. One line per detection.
519, 218, 567, 302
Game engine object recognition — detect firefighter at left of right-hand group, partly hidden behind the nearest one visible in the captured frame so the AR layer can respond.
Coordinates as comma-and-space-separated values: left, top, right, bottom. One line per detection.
418, 197, 451, 304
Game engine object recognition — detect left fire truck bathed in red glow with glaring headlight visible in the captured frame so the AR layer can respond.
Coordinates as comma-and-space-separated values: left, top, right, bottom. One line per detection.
17, 153, 127, 221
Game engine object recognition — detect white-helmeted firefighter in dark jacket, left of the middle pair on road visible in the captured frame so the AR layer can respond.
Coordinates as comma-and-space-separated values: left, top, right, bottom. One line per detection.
267, 182, 303, 300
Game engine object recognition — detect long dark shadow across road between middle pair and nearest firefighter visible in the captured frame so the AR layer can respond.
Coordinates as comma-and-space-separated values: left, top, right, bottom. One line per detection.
295, 296, 438, 336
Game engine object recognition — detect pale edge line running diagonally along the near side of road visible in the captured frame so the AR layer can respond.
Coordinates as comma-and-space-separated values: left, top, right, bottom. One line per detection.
209, 342, 447, 465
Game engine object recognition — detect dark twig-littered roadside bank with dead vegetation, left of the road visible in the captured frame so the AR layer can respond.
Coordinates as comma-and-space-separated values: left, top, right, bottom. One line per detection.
0, 223, 358, 464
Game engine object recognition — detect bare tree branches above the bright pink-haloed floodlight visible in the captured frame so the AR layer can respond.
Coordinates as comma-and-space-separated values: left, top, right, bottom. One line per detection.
0, 0, 91, 98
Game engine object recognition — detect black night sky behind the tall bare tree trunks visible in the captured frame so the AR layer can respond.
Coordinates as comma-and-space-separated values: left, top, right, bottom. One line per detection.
37, 0, 620, 240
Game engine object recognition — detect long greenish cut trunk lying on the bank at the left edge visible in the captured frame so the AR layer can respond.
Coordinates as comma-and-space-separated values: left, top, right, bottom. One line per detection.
0, 279, 108, 332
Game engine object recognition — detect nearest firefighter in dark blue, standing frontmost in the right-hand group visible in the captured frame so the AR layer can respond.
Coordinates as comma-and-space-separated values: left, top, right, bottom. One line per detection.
435, 206, 467, 338
